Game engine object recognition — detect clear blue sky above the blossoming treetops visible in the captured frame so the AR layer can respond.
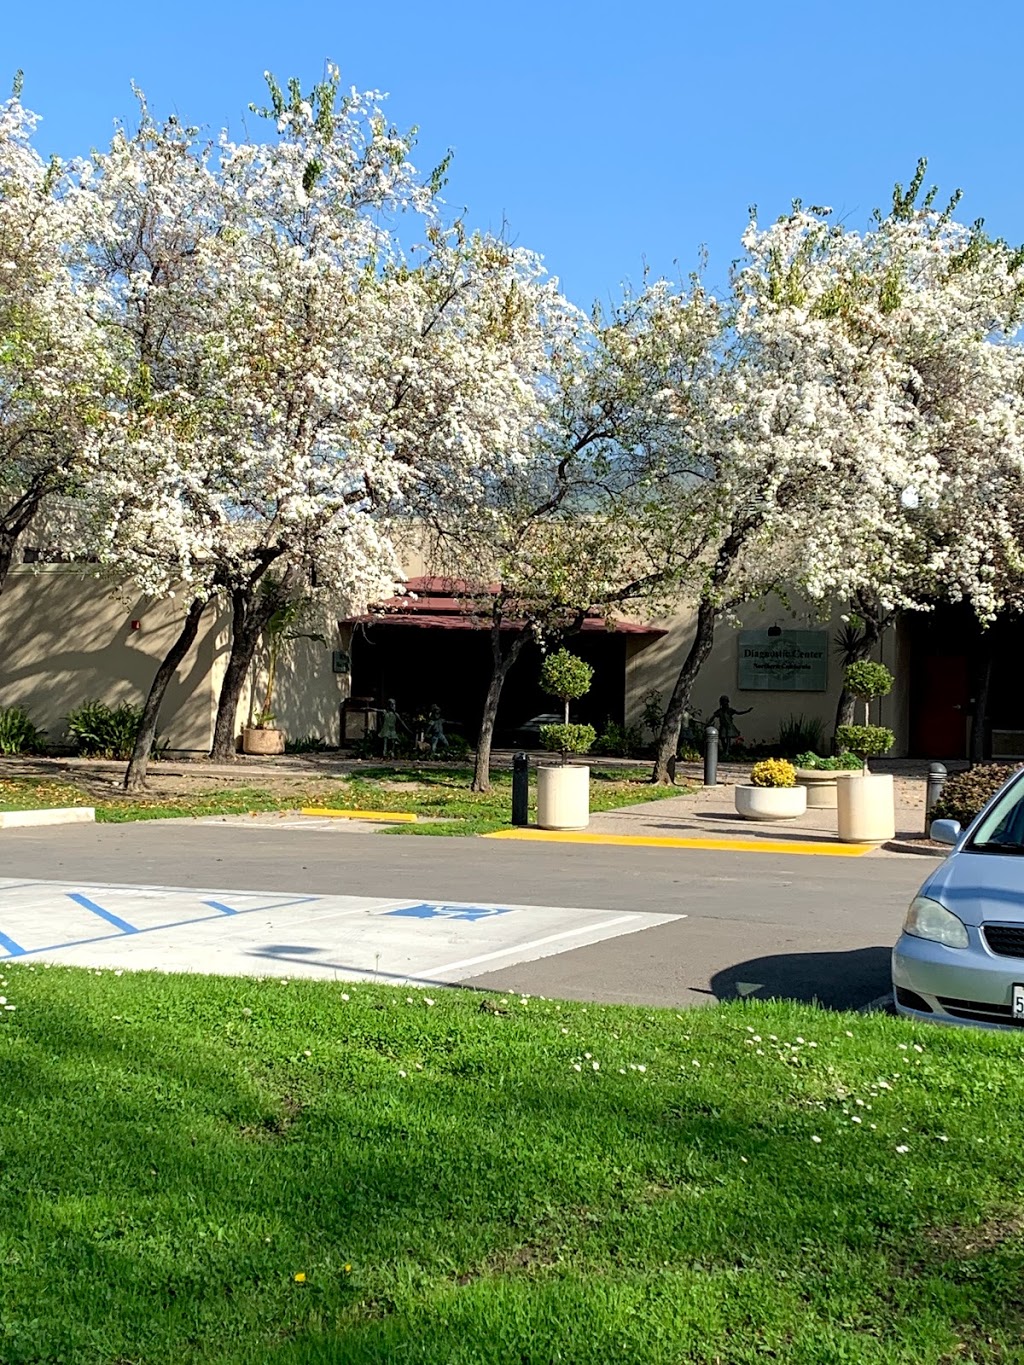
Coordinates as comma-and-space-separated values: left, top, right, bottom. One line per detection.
0, 0, 1024, 306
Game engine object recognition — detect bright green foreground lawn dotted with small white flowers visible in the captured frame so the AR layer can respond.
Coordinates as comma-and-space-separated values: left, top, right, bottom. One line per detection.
0, 966, 1024, 1365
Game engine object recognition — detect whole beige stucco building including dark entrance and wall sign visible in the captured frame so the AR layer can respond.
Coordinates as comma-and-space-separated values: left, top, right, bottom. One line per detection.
0, 565, 917, 756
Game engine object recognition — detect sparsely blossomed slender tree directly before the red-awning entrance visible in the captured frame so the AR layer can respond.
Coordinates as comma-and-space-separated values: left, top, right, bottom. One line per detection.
419, 277, 715, 792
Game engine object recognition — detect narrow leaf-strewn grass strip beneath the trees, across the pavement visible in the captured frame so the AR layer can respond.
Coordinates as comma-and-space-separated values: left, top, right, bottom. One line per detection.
0, 767, 685, 835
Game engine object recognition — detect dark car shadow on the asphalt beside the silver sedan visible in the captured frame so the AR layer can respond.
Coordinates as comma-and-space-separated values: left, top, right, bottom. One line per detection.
711, 947, 892, 1010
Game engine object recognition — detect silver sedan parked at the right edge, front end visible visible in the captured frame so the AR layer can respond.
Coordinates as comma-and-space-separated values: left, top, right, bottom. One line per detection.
893, 770, 1024, 1028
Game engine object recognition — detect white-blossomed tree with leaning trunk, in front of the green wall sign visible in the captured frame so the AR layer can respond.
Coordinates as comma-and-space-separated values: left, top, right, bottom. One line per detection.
644, 167, 1021, 781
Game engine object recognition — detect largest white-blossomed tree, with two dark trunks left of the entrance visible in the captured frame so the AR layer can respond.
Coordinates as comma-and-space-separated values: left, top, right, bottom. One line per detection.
94, 66, 589, 782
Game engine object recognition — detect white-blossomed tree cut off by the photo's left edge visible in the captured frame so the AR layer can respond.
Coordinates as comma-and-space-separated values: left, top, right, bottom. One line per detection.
0, 82, 111, 591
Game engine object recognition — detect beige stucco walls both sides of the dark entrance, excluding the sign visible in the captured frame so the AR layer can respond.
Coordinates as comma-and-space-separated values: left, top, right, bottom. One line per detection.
0, 565, 909, 756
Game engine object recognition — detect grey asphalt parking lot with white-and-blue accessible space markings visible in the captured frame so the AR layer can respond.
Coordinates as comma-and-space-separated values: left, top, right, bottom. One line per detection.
0, 820, 933, 1007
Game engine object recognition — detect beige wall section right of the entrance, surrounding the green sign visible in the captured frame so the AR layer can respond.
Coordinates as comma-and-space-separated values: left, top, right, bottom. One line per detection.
625, 598, 908, 756
